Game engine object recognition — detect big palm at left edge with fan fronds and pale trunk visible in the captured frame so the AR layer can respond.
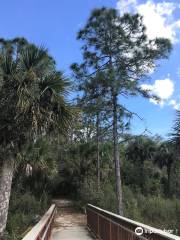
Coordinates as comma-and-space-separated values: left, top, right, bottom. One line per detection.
0, 38, 72, 236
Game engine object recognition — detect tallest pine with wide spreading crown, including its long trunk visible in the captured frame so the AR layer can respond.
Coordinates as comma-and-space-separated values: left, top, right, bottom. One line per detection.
72, 8, 171, 215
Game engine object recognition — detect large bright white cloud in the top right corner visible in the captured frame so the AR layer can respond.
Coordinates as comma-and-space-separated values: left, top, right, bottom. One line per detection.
117, 0, 180, 43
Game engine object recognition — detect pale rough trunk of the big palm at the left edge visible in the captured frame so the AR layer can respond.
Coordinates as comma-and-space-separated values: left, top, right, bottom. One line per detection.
0, 159, 14, 239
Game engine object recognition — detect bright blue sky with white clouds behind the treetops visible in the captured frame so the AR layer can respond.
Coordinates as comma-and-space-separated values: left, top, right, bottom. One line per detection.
0, 0, 180, 137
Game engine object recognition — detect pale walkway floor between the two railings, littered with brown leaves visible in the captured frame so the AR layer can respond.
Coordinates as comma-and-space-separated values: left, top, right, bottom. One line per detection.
52, 200, 93, 240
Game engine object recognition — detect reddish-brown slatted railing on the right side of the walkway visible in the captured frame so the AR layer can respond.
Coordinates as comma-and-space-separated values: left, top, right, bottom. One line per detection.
86, 204, 180, 240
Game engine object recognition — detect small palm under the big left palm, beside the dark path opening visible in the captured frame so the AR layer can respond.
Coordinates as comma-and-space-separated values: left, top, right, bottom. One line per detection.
16, 136, 58, 197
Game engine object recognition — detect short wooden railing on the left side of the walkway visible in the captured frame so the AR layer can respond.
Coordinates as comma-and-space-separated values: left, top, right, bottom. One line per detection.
22, 204, 56, 240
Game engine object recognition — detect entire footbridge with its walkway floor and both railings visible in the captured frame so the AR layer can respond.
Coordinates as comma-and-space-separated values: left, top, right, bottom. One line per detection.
23, 200, 180, 240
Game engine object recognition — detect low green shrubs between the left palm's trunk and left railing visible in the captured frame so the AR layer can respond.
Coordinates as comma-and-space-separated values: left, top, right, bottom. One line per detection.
6, 189, 50, 240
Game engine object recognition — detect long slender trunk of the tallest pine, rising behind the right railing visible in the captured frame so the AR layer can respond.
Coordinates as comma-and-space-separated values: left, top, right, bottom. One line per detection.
113, 93, 123, 216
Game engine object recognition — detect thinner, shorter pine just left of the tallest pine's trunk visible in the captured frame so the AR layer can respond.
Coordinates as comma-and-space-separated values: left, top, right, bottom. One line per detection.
76, 72, 108, 189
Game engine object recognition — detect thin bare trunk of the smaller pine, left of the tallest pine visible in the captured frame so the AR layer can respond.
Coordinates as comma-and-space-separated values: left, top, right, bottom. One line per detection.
96, 114, 100, 190
